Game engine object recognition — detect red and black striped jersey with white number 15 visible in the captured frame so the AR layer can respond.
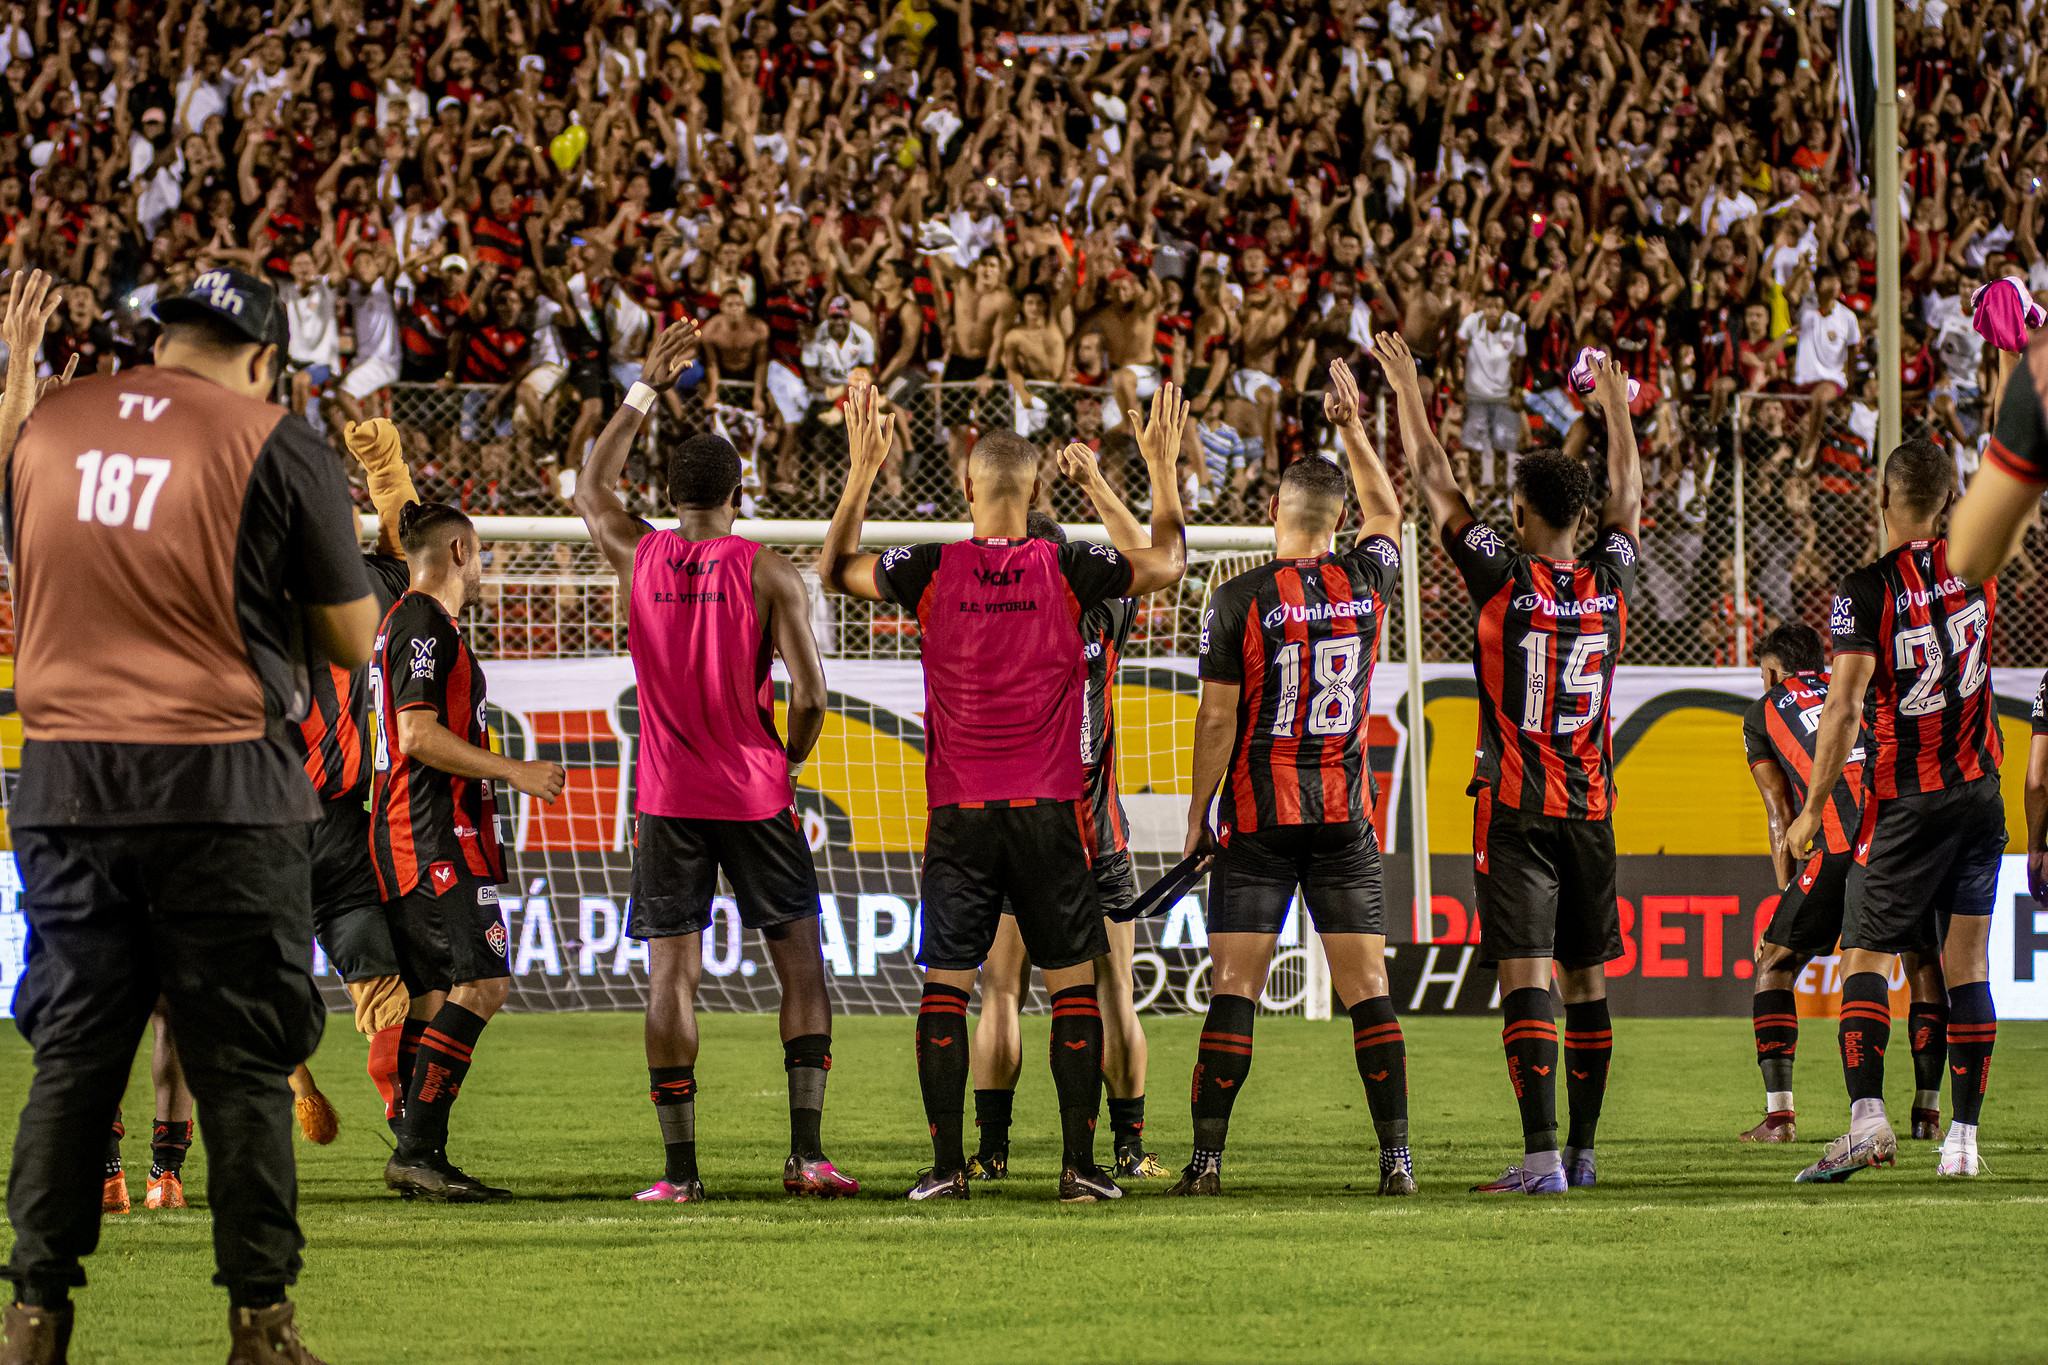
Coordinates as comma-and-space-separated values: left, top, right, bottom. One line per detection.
1444, 522, 1638, 821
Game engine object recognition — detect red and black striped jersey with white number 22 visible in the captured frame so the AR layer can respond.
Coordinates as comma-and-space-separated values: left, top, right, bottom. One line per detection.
1829, 540, 2005, 800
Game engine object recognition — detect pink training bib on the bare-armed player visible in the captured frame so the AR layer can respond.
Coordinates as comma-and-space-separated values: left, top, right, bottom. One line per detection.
627, 530, 788, 821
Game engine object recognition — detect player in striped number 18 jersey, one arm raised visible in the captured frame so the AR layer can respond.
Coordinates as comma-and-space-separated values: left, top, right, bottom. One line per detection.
1167, 360, 1415, 1195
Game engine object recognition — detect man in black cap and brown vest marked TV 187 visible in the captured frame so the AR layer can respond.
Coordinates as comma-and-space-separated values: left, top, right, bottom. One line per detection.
0, 270, 377, 1365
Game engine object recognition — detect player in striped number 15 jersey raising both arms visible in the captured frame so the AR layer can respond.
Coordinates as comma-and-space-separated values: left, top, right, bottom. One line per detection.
1374, 332, 1630, 1195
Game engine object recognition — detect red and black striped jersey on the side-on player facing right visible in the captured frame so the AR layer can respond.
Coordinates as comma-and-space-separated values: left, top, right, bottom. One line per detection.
369, 591, 504, 900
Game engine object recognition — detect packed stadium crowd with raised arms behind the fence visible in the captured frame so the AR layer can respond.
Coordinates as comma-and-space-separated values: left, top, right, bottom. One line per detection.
0, 0, 2048, 663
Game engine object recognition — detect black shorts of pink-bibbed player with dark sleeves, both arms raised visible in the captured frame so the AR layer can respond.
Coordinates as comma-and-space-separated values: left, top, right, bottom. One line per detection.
918, 800, 1110, 972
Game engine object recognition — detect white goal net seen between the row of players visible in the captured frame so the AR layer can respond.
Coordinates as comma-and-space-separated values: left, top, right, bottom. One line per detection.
399, 520, 1384, 1013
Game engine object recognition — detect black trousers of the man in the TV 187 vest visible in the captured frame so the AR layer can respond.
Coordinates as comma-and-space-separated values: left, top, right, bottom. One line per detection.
6, 825, 326, 1291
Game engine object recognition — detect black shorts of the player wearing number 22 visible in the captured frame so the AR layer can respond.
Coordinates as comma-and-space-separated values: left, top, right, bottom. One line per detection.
1841, 776, 2005, 954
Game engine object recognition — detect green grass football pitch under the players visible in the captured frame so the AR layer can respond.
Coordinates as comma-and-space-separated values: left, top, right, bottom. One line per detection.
12, 1013, 2048, 1365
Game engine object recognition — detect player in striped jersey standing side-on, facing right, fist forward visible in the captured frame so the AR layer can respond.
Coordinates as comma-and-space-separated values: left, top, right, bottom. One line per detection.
371, 503, 563, 1203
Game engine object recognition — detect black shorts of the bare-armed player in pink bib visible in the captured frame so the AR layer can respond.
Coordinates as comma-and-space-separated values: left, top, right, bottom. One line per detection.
627, 806, 819, 939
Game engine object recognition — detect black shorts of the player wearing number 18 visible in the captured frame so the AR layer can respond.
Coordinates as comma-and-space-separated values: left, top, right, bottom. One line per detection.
1208, 821, 1386, 933
